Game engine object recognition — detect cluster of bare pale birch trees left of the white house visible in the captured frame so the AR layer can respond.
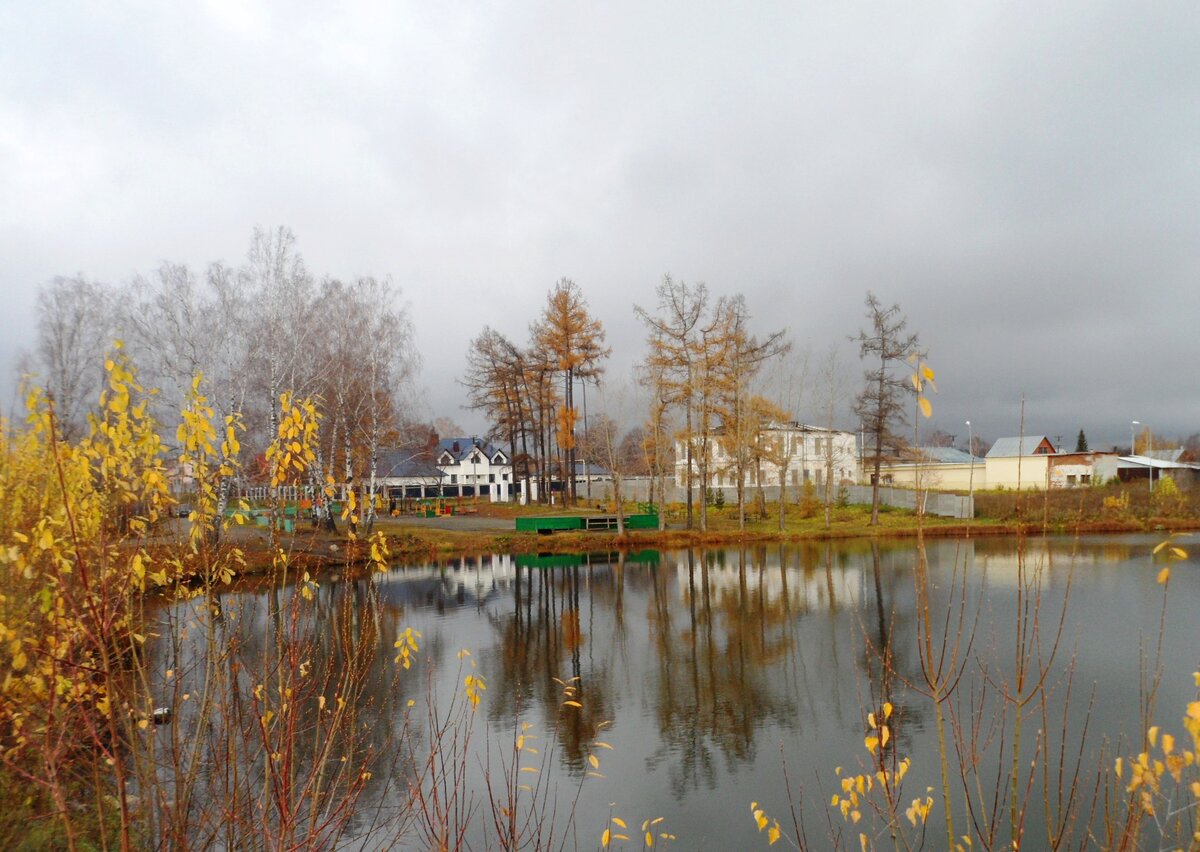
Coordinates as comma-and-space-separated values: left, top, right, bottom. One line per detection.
24, 227, 420, 526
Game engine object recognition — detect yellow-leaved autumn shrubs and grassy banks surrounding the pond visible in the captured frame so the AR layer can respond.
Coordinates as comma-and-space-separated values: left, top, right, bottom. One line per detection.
9, 352, 1200, 852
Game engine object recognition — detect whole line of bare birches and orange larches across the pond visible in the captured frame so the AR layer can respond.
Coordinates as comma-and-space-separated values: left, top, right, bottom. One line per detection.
37, 227, 1200, 530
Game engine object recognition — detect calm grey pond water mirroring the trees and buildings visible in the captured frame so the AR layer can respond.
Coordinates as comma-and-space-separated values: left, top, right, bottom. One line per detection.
154, 535, 1200, 850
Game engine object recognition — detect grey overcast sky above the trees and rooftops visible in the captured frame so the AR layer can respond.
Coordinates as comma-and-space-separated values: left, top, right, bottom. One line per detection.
0, 0, 1200, 449
